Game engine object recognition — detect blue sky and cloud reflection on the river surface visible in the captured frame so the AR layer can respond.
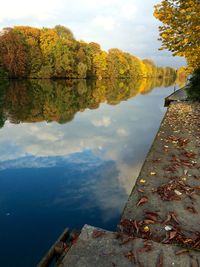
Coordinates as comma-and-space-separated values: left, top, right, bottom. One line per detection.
0, 82, 173, 267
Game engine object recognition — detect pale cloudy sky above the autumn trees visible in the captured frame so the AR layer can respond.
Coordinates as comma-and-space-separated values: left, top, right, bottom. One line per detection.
0, 0, 185, 67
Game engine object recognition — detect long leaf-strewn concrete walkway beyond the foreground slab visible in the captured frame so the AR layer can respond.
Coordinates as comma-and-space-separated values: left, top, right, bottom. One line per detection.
120, 102, 200, 249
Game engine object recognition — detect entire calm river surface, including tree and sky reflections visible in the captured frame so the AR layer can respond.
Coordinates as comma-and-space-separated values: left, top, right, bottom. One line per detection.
0, 81, 173, 267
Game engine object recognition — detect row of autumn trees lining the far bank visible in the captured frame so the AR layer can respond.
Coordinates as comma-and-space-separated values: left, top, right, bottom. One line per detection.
0, 25, 176, 79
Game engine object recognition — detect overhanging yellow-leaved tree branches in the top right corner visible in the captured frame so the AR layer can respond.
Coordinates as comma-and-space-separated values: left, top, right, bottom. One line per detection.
154, 0, 200, 72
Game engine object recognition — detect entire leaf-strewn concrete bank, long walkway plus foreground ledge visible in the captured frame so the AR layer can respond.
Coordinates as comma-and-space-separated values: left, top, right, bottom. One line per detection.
38, 96, 200, 267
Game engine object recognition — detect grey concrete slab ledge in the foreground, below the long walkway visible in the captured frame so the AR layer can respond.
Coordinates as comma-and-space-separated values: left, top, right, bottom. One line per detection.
58, 225, 200, 267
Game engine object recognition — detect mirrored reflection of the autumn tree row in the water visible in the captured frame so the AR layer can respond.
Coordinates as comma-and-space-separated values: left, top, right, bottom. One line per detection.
0, 78, 174, 127
